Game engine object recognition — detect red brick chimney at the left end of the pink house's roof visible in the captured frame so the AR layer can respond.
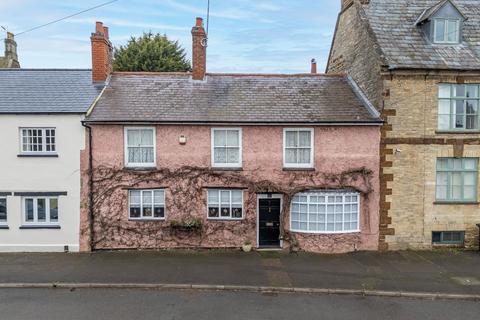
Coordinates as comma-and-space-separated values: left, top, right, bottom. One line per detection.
90, 22, 113, 82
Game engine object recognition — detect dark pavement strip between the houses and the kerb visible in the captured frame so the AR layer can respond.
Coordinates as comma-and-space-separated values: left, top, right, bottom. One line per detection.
0, 250, 480, 300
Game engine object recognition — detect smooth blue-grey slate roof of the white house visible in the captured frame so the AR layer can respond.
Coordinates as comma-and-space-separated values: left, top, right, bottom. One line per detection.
0, 69, 102, 114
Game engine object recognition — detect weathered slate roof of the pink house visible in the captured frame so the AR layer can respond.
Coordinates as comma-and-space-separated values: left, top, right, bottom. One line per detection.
86, 73, 380, 123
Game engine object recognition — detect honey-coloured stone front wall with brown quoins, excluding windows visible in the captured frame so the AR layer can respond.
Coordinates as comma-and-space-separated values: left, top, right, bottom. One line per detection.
380, 73, 480, 250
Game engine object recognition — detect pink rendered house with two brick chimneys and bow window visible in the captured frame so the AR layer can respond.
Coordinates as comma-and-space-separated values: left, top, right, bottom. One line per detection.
80, 19, 382, 253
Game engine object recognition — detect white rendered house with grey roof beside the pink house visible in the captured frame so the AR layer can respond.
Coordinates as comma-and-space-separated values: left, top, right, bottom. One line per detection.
0, 69, 102, 252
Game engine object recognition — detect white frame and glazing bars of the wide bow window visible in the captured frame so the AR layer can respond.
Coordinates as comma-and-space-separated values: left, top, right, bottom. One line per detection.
289, 191, 361, 234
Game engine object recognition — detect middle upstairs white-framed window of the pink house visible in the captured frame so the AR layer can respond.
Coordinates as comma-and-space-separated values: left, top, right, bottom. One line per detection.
212, 128, 242, 168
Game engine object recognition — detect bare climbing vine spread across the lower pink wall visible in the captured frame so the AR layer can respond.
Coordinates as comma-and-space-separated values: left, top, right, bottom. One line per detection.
90, 166, 373, 250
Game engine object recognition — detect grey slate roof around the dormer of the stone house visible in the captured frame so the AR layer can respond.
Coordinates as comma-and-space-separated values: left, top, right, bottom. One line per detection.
362, 0, 480, 70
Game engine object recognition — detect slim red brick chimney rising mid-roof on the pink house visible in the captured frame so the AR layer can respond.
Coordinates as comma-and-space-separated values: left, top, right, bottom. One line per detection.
192, 18, 207, 80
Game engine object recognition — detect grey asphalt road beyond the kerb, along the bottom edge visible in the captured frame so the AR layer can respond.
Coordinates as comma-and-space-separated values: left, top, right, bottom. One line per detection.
0, 289, 480, 320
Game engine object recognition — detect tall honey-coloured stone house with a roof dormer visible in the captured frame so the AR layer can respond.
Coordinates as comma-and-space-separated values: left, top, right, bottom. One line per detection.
327, 0, 480, 250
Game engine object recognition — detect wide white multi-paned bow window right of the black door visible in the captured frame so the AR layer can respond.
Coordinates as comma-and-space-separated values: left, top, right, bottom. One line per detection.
290, 192, 360, 233
